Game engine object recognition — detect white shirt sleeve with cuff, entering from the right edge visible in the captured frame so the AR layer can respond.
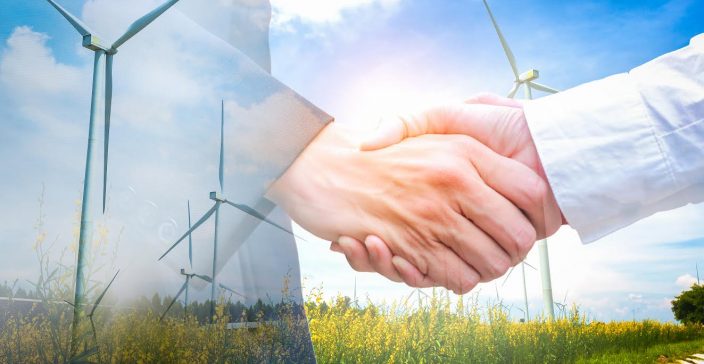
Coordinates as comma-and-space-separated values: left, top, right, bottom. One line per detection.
525, 34, 704, 243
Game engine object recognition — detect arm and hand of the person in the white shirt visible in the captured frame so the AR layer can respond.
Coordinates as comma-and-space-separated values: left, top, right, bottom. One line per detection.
331, 34, 704, 287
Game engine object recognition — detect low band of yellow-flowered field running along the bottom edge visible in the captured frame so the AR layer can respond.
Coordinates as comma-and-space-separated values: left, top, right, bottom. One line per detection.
0, 291, 704, 363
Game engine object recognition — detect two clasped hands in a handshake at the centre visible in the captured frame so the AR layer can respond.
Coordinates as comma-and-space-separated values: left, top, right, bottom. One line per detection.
270, 95, 564, 294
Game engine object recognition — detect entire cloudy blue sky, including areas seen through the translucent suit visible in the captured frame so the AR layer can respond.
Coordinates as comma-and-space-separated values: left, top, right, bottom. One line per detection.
0, 0, 704, 320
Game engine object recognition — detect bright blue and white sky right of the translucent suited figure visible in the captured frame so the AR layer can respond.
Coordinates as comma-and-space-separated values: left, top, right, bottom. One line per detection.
264, 0, 704, 320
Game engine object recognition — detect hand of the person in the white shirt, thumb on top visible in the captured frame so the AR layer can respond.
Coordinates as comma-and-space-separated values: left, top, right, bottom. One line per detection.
331, 94, 564, 286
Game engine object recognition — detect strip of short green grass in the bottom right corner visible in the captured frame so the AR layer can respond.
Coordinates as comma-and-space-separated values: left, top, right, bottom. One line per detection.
577, 339, 704, 364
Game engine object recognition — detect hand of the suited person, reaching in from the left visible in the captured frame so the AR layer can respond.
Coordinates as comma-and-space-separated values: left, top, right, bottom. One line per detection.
270, 124, 547, 293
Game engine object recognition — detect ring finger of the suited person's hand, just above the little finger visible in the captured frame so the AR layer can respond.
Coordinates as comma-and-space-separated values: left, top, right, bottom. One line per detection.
440, 210, 516, 282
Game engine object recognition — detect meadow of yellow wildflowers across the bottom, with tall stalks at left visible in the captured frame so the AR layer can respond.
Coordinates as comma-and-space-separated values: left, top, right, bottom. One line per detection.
0, 194, 704, 363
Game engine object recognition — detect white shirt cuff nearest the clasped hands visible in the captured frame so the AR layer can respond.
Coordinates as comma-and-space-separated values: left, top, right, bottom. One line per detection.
525, 73, 678, 243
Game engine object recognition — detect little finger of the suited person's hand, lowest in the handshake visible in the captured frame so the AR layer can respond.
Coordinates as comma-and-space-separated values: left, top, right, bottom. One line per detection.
420, 242, 481, 294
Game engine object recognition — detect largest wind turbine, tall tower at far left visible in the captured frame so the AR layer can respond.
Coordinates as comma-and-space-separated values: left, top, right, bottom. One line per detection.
47, 0, 183, 354
